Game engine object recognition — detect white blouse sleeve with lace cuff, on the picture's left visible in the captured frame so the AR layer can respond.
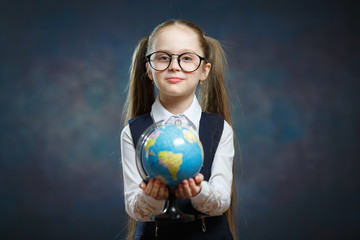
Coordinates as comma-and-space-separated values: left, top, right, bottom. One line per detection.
121, 126, 165, 221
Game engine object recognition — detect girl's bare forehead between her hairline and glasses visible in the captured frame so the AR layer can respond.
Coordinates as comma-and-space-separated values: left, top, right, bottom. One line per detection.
152, 26, 203, 53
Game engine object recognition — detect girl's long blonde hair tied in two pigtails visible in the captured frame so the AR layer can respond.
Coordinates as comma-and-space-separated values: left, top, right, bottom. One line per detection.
124, 20, 237, 239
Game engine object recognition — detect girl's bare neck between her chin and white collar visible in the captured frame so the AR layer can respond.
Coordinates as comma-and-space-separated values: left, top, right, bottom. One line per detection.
159, 95, 194, 115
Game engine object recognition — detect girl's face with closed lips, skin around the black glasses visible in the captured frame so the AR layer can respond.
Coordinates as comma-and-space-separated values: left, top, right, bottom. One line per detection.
146, 26, 211, 99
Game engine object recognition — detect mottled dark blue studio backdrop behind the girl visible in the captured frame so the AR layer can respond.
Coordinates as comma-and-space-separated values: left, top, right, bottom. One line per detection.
0, 0, 360, 240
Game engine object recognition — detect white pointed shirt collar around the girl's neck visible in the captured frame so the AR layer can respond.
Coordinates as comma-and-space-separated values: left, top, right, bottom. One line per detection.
151, 95, 201, 129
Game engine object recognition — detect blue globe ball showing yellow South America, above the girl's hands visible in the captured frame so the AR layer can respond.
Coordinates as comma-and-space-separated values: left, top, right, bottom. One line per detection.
136, 124, 204, 187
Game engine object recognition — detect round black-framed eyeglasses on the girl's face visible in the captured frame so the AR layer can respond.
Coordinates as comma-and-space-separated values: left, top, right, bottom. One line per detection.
146, 51, 205, 72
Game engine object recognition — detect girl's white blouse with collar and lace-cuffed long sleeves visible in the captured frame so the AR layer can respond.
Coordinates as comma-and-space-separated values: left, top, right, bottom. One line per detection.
121, 96, 234, 221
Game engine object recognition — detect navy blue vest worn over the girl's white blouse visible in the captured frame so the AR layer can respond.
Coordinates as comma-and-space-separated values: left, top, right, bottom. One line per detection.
129, 112, 233, 240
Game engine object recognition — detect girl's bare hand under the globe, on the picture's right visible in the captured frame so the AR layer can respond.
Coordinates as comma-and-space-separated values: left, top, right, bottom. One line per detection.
175, 173, 204, 199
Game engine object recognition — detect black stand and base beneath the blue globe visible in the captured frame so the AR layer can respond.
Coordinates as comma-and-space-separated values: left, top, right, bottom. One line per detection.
151, 187, 195, 222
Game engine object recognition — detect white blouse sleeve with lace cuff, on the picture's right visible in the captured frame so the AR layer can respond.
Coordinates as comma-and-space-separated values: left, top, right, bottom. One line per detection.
191, 121, 234, 216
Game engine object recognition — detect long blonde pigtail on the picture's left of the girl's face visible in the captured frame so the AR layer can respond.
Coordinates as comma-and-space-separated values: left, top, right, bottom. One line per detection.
125, 37, 155, 125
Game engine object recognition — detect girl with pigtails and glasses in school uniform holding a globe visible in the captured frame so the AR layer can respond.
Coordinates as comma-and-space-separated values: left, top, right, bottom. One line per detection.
121, 20, 236, 239
